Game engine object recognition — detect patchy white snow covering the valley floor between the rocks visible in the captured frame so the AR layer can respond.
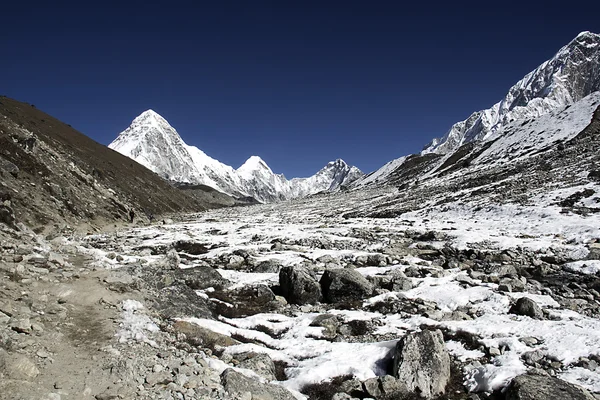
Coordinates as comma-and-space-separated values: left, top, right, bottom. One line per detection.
77, 187, 600, 392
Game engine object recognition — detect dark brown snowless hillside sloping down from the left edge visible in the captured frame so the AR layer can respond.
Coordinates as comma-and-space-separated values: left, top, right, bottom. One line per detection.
0, 97, 211, 232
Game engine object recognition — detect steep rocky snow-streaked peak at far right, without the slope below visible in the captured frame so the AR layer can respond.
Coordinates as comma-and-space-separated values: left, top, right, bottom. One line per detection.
421, 32, 600, 154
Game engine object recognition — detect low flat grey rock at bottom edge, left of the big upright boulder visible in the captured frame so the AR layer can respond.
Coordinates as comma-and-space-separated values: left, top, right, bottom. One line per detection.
221, 368, 296, 400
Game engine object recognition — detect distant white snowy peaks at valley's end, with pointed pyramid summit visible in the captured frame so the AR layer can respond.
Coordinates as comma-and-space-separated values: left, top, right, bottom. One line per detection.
108, 110, 363, 202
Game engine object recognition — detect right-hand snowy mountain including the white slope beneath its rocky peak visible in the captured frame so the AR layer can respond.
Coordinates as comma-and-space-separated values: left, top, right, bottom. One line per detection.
353, 32, 600, 186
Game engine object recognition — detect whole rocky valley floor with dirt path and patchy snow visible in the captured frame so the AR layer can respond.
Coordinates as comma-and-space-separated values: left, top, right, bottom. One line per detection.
0, 187, 600, 400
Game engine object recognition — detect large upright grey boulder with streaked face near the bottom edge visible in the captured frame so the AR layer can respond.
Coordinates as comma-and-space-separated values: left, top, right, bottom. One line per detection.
394, 330, 450, 399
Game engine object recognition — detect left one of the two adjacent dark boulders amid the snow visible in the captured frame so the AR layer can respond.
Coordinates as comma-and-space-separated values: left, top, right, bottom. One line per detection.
279, 266, 321, 304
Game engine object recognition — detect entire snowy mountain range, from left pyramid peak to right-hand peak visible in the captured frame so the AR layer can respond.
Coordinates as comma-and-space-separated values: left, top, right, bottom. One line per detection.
109, 31, 600, 202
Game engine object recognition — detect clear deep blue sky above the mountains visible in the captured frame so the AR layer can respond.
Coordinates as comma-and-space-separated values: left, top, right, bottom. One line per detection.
0, 0, 600, 178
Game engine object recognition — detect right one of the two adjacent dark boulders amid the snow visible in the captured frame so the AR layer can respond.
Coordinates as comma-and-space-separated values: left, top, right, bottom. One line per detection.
320, 268, 373, 303
